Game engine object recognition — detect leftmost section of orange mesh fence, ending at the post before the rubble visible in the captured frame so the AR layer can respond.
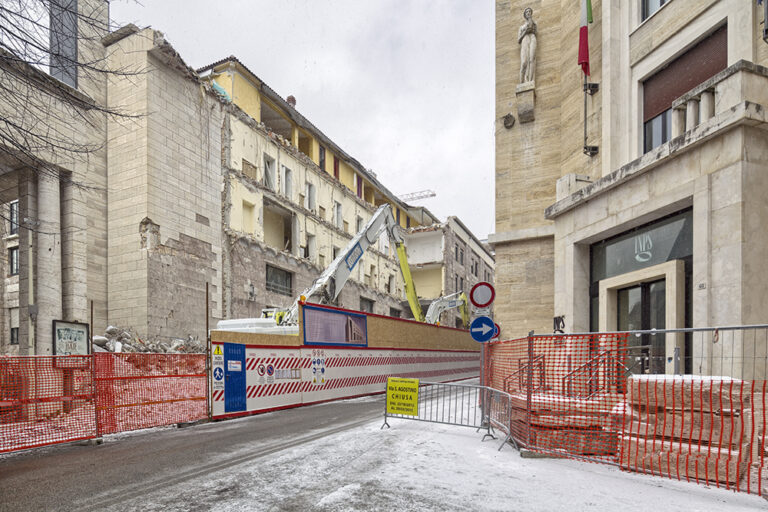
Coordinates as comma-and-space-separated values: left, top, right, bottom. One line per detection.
0, 356, 96, 452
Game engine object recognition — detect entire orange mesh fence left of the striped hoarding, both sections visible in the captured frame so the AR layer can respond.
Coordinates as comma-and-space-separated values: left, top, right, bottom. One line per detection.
0, 353, 207, 452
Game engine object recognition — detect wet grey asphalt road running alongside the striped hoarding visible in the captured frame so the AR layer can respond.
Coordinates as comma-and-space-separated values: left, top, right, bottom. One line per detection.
0, 397, 384, 512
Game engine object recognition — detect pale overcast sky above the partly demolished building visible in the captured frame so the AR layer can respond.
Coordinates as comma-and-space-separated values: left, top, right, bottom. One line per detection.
110, 0, 494, 238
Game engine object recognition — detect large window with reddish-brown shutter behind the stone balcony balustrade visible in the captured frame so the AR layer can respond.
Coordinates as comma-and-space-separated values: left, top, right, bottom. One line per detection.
643, 25, 728, 153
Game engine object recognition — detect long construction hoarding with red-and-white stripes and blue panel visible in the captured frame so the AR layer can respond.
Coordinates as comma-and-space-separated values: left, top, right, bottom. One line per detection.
211, 305, 480, 417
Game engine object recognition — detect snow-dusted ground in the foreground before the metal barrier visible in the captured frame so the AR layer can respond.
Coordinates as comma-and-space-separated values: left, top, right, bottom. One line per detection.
105, 404, 766, 512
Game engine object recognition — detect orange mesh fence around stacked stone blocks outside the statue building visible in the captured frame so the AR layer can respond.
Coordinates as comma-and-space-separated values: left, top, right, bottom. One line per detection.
486, 333, 768, 494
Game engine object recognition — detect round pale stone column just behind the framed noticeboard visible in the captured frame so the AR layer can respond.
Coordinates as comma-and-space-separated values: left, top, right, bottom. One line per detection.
35, 173, 62, 355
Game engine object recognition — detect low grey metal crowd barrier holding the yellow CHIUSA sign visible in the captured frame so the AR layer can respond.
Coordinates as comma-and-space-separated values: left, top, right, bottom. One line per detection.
381, 381, 517, 450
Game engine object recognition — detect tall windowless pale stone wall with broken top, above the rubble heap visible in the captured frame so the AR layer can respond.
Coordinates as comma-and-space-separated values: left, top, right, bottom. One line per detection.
109, 30, 223, 339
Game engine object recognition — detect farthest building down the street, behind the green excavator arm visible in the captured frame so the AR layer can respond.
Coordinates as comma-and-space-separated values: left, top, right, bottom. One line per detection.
408, 217, 494, 327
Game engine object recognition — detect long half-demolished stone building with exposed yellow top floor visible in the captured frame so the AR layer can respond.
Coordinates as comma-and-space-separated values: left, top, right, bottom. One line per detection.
0, 0, 492, 355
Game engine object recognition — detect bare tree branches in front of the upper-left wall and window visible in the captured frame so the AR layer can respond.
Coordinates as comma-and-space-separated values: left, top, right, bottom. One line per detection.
0, 0, 145, 198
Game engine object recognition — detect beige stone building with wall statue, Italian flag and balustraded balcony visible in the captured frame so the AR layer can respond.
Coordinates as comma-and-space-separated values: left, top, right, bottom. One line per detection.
489, 0, 768, 377
